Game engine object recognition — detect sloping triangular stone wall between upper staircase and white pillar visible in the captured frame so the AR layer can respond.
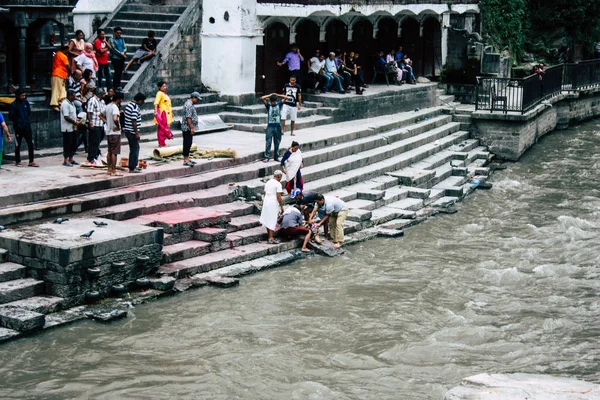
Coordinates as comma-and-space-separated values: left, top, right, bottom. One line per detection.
124, 0, 203, 96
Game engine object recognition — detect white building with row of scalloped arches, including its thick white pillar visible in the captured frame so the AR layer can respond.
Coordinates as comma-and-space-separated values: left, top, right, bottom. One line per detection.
201, 0, 480, 104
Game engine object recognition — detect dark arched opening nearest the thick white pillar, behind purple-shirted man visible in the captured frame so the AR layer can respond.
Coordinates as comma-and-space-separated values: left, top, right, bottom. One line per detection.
255, 22, 290, 94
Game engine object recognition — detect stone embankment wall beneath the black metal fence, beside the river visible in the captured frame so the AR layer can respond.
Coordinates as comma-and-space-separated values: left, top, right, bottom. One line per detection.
472, 89, 600, 161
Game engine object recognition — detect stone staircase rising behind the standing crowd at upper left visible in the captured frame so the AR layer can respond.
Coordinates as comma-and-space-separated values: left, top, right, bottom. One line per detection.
102, 0, 187, 87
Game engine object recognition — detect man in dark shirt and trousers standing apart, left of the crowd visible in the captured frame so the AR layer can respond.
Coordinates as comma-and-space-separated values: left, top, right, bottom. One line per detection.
8, 88, 39, 167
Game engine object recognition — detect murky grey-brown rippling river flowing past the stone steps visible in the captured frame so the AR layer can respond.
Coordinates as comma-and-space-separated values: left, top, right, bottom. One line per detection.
0, 120, 600, 400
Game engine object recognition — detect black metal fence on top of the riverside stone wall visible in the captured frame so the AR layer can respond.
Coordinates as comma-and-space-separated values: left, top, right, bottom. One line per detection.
475, 59, 600, 114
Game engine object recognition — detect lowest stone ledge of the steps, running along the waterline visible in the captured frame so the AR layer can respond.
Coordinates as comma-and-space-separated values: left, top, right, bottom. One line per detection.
0, 170, 495, 345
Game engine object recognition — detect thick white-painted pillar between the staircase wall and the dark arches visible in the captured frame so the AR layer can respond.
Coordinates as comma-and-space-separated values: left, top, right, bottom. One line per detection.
202, 0, 263, 104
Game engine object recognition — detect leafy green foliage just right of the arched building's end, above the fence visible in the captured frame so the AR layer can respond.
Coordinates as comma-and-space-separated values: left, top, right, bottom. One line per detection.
479, 0, 529, 59
